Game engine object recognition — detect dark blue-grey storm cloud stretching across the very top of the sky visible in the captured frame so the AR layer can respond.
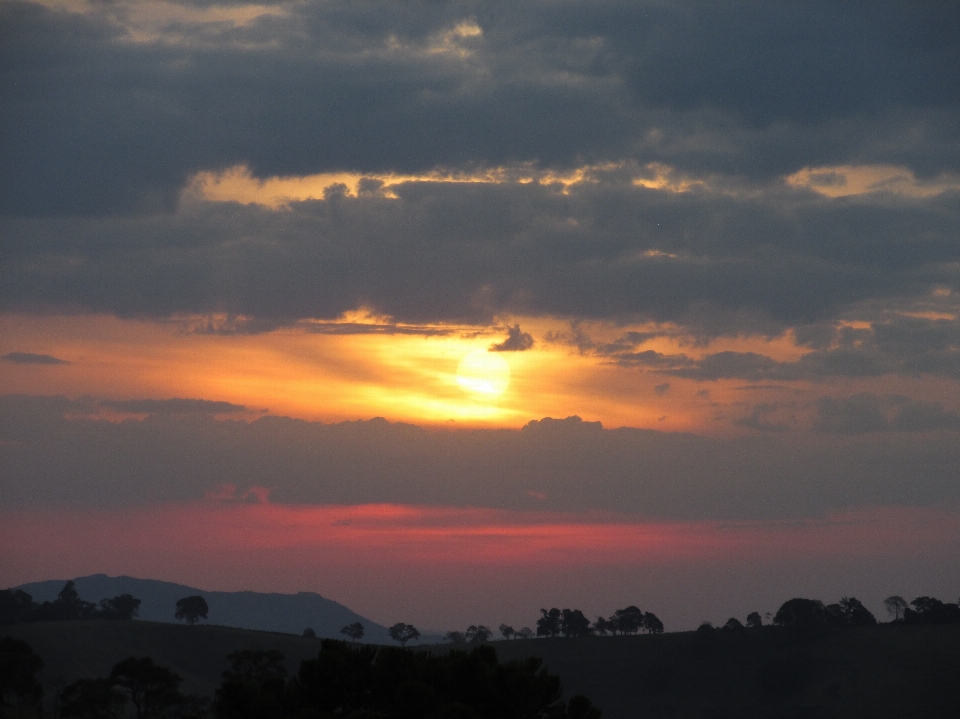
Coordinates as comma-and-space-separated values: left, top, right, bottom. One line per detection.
0, 0, 960, 214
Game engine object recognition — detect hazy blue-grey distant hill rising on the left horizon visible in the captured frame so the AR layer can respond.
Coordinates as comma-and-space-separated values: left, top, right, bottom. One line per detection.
17, 574, 412, 644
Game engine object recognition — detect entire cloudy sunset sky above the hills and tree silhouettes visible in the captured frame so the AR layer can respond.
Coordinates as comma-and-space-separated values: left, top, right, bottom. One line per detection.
0, 0, 960, 631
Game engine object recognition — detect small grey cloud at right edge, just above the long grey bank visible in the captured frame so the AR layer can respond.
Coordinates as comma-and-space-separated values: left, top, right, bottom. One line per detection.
814, 392, 960, 434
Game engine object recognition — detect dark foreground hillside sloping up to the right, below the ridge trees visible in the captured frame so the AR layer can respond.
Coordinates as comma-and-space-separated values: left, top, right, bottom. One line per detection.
494, 625, 960, 719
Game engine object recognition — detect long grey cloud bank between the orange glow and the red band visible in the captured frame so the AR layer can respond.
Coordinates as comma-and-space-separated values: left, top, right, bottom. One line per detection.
0, 395, 960, 519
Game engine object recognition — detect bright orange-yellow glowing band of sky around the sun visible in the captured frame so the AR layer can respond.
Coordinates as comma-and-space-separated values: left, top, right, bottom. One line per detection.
0, 312, 952, 433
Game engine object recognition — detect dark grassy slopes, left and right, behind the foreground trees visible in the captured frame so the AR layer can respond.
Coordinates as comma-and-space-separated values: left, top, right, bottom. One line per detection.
7, 621, 960, 719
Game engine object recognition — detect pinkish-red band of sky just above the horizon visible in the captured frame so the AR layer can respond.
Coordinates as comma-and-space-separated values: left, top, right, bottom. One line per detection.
0, 501, 960, 626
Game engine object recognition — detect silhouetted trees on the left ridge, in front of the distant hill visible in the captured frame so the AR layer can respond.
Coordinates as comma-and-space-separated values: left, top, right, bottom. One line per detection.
0, 580, 209, 626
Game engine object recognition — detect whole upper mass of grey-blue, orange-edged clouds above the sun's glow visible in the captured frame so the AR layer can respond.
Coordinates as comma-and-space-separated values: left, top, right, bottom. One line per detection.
0, 0, 960, 344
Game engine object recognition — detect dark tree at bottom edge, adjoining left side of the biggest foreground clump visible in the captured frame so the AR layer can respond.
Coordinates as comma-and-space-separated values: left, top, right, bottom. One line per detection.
214, 645, 288, 719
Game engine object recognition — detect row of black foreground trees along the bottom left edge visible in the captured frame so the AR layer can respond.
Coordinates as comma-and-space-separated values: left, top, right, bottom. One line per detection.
0, 637, 600, 719
